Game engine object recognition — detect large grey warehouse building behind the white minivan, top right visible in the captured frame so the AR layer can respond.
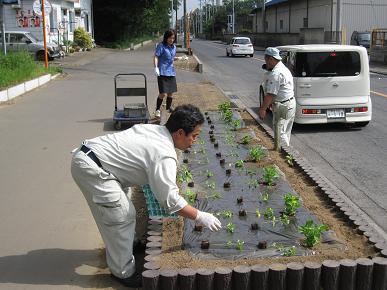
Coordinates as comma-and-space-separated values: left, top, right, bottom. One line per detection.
253, 0, 387, 44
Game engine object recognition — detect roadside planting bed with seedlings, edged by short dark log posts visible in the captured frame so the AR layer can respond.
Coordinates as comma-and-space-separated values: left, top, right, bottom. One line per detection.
143, 82, 387, 290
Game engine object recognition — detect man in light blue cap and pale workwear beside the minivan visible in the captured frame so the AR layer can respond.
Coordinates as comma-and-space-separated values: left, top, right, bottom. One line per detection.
258, 47, 296, 146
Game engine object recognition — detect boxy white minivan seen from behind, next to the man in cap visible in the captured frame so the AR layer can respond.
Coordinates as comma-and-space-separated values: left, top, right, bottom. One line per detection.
260, 44, 372, 127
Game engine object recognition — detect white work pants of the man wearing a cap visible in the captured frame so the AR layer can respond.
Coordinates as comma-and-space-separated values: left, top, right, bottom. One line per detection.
273, 98, 296, 146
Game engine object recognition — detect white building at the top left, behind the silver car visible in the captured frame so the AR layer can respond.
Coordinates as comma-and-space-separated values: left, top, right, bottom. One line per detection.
0, 0, 94, 44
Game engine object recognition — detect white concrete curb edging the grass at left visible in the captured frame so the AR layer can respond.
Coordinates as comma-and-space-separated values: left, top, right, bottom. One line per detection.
0, 74, 60, 104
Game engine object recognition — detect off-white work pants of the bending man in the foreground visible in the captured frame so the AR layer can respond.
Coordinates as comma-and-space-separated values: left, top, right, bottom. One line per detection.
71, 149, 136, 278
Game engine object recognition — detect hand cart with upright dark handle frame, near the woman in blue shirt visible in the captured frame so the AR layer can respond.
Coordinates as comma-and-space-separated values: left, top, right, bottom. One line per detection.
113, 73, 149, 130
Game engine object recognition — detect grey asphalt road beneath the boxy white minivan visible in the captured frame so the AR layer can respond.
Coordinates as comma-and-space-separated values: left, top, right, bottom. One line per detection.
192, 39, 387, 232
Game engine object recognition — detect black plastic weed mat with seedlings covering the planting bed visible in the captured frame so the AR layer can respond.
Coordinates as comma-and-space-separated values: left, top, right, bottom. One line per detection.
180, 112, 343, 259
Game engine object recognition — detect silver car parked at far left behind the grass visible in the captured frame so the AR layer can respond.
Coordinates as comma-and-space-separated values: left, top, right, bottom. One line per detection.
0, 31, 61, 60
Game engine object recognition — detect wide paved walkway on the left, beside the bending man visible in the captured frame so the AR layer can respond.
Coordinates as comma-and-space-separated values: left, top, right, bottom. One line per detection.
0, 46, 168, 290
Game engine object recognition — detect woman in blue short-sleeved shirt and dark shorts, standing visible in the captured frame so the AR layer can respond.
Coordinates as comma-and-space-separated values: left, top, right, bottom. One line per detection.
153, 29, 178, 118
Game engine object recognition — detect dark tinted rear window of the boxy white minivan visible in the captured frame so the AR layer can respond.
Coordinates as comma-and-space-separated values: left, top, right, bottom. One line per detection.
294, 51, 361, 77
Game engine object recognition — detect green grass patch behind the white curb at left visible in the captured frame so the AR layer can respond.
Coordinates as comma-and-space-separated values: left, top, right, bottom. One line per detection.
0, 51, 62, 90
